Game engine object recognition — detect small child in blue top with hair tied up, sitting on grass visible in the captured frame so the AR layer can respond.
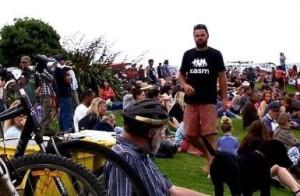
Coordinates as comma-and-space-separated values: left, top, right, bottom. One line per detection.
217, 115, 239, 155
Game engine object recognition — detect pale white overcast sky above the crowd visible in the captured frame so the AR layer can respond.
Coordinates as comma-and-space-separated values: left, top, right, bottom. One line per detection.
0, 0, 300, 65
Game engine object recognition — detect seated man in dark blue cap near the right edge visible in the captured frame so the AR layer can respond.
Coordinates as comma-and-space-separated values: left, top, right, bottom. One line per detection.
262, 101, 280, 136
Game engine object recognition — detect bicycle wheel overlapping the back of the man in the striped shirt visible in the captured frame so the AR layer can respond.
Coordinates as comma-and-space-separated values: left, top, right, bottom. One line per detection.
52, 140, 150, 196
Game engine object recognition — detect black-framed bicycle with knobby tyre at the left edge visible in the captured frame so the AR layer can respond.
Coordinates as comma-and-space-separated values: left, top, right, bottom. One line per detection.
0, 68, 102, 195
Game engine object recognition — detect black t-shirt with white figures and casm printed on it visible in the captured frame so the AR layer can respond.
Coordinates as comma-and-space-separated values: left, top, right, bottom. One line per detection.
180, 47, 225, 104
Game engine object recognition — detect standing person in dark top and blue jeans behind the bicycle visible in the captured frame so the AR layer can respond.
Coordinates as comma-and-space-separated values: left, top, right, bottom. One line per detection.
54, 55, 73, 132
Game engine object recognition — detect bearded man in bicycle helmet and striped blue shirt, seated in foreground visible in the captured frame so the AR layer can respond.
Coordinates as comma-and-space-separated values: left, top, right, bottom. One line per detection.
104, 99, 204, 196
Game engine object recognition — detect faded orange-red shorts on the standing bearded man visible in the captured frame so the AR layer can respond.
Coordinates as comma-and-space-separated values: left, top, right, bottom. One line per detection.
184, 104, 217, 137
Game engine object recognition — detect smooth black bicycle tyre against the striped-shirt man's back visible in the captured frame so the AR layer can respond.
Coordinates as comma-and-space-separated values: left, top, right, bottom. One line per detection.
52, 139, 150, 196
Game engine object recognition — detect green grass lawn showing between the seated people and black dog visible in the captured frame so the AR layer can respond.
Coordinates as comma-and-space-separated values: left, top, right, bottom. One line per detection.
116, 113, 300, 195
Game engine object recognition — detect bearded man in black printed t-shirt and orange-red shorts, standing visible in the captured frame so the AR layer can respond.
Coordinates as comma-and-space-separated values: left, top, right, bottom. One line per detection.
178, 24, 227, 173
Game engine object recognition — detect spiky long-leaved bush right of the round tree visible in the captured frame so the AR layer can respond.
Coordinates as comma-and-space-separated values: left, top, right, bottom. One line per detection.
63, 37, 121, 98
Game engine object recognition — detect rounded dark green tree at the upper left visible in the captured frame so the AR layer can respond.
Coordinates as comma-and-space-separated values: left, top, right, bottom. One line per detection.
0, 17, 62, 66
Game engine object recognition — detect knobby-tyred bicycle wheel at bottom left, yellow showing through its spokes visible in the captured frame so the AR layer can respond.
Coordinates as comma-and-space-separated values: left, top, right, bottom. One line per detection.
8, 153, 101, 196
